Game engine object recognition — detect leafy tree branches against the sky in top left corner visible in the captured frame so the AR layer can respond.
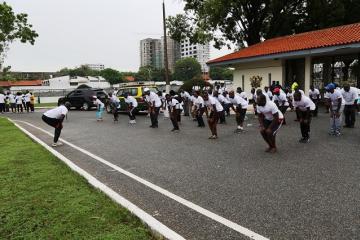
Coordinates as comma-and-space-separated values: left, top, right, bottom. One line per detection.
0, 2, 39, 69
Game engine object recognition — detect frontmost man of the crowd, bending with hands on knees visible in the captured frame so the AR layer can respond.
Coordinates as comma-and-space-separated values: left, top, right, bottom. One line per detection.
256, 94, 283, 153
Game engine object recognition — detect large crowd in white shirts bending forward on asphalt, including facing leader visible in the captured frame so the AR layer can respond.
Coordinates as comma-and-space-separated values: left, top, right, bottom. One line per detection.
38, 83, 360, 153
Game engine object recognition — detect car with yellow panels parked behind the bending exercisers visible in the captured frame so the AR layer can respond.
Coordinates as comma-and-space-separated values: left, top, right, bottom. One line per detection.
106, 84, 158, 113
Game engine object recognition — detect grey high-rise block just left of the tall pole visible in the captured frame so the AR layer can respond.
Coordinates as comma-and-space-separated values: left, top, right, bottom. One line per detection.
140, 38, 162, 69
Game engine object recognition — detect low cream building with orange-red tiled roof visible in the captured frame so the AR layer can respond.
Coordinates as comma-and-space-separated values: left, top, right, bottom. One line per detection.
207, 23, 360, 92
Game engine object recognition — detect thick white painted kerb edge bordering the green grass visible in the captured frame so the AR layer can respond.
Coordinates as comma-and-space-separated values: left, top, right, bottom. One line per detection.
9, 119, 185, 240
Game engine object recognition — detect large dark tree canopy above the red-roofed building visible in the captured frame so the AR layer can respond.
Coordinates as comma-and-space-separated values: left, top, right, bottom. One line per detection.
167, 0, 360, 48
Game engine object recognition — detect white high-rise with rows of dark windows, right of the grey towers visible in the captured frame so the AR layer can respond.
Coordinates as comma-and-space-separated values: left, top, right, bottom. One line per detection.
181, 39, 210, 73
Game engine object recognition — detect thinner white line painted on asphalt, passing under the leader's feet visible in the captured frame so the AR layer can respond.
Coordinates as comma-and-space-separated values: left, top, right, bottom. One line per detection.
17, 121, 269, 240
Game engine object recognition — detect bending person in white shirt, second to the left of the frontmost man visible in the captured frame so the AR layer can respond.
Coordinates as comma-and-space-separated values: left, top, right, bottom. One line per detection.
204, 91, 224, 139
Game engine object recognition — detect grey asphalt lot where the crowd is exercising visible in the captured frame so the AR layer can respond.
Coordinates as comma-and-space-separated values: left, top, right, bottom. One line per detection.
8, 111, 360, 240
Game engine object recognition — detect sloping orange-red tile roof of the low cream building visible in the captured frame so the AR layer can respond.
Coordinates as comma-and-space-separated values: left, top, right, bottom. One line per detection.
208, 23, 360, 64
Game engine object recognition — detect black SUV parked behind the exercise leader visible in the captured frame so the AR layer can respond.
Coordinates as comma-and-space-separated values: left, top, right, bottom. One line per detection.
58, 88, 109, 110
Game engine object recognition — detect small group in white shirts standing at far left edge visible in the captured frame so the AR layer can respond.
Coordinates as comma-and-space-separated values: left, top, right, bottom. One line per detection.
0, 91, 35, 114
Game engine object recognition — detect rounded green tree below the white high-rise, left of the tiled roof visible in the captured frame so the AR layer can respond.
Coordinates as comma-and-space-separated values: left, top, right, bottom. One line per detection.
173, 57, 202, 81
